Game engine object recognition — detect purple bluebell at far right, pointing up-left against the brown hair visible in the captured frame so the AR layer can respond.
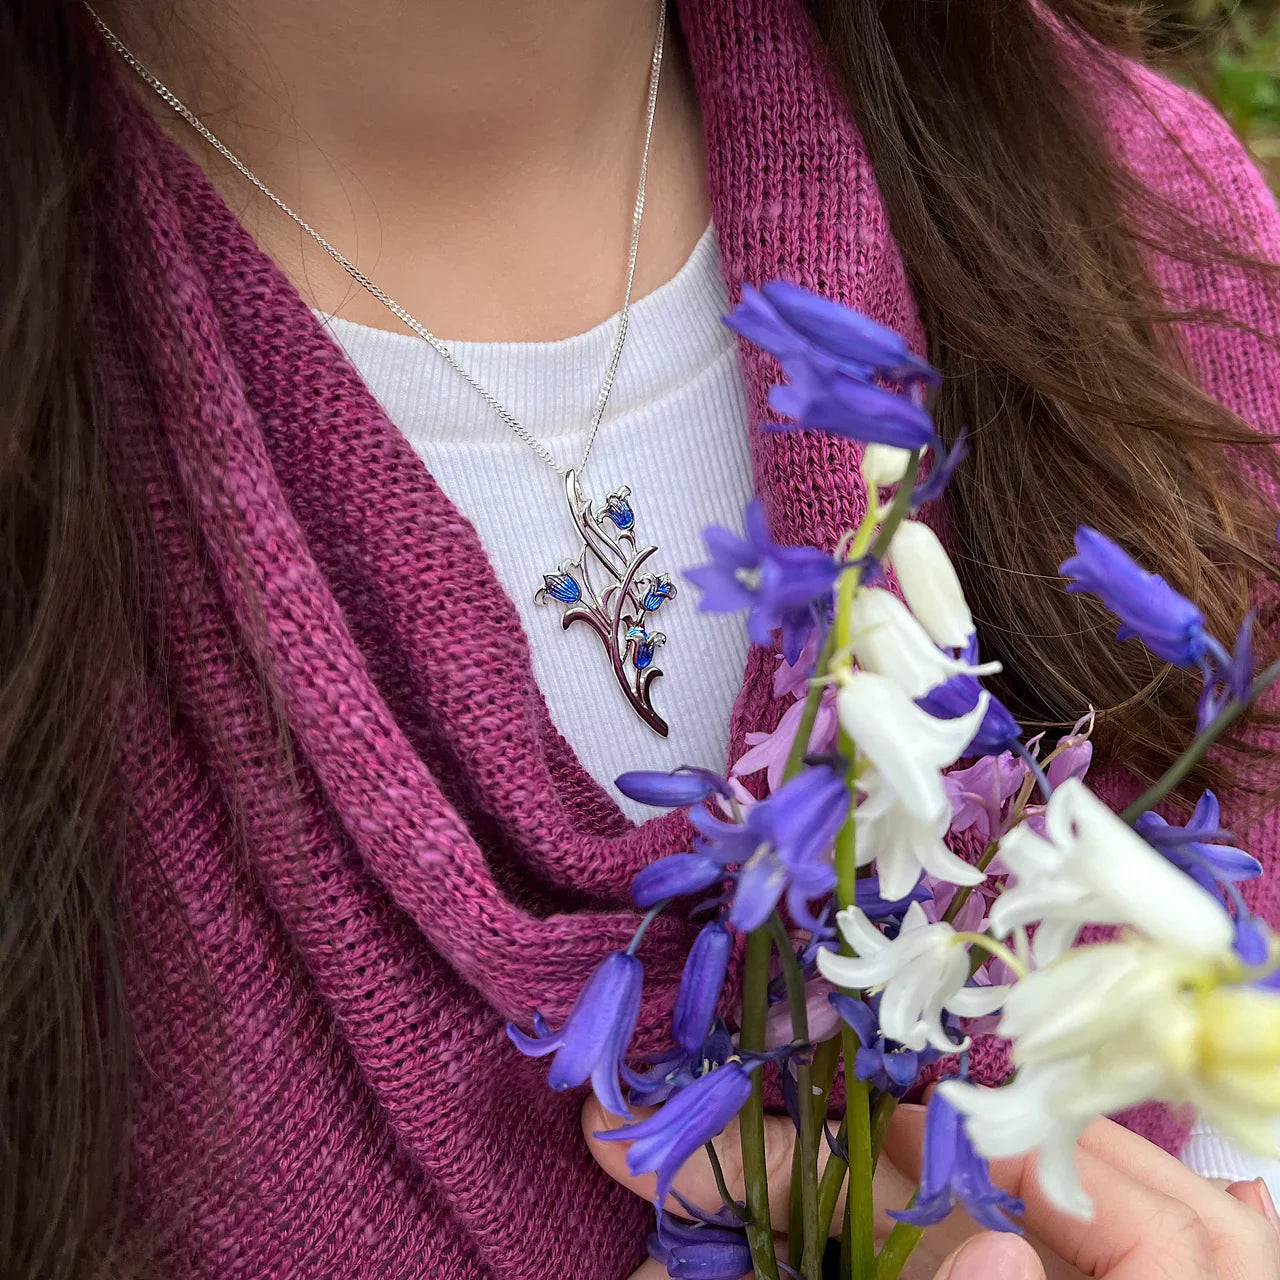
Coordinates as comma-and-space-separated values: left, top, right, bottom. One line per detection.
1061, 525, 1226, 668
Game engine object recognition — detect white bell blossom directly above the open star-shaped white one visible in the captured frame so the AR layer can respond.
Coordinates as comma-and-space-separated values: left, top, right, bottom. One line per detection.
854, 769, 984, 899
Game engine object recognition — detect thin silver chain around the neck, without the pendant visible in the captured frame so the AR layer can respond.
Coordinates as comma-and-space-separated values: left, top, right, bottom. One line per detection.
84, 0, 667, 476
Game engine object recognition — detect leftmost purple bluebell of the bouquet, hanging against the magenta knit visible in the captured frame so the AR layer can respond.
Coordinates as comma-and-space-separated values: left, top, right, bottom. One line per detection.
507, 951, 644, 1117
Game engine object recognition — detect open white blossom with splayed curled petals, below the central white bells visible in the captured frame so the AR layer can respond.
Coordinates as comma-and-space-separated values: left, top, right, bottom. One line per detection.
818, 902, 1007, 1053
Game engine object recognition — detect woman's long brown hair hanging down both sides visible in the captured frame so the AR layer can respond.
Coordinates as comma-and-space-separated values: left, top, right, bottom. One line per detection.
0, 0, 1276, 1280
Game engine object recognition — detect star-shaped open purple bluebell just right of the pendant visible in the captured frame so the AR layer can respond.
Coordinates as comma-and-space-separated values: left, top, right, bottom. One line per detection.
685, 499, 841, 663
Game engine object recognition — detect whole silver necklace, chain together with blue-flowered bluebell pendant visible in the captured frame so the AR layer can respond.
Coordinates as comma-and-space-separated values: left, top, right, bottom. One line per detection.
84, 0, 676, 736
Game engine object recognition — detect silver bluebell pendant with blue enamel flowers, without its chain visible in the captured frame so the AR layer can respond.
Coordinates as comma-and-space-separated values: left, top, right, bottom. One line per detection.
534, 471, 676, 737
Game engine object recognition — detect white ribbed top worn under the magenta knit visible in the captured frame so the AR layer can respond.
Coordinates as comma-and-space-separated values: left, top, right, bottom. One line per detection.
317, 229, 1280, 1199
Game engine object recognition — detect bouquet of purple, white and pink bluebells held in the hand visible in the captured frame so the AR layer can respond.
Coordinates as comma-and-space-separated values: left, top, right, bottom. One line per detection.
509, 282, 1280, 1280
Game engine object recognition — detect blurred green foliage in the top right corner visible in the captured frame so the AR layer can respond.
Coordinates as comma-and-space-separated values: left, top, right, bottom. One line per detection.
1134, 0, 1280, 191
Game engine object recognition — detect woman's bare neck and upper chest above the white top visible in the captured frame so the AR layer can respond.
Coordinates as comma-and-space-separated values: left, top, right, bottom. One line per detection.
102, 0, 708, 340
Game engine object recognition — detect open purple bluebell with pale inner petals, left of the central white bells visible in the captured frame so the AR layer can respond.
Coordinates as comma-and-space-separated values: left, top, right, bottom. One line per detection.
690, 764, 849, 932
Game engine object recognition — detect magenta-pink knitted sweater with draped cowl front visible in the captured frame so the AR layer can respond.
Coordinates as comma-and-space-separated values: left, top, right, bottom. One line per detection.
104, 0, 1280, 1280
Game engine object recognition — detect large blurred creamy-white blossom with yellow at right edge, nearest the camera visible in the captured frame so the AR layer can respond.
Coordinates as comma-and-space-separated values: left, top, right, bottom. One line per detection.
940, 931, 1259, 1220
